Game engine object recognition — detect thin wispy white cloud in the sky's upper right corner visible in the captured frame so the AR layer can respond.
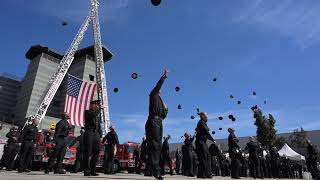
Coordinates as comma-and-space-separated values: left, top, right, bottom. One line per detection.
235, 0, 320, 48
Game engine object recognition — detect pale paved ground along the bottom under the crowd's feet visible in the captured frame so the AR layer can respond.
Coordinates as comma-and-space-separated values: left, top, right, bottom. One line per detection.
0, 171, 296, 180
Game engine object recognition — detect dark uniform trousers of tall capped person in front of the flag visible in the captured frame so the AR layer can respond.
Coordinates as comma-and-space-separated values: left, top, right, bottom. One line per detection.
83, 129, 100, 174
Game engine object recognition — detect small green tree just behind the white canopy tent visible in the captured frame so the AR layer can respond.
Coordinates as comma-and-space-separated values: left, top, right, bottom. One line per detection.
289, 127, 307, 148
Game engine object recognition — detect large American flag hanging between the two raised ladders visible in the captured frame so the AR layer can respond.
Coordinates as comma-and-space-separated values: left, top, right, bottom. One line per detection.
64, 74, 97, 127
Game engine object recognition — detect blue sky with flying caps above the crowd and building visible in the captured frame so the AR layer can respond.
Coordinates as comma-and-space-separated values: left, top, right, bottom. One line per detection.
0, 0, 320, 142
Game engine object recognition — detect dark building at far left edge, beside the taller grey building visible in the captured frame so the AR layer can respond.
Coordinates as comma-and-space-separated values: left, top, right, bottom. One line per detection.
0, 73, 21, 123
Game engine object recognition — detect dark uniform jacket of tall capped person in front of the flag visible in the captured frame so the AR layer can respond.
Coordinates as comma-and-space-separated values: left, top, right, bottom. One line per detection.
84, 109, 102, 138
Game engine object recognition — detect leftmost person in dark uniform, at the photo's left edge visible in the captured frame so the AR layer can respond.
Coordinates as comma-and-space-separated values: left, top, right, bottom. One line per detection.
1, 127, 20, 171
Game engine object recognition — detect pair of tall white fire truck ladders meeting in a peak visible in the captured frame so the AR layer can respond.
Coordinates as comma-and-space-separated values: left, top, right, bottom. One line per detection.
24, 0, 110, 133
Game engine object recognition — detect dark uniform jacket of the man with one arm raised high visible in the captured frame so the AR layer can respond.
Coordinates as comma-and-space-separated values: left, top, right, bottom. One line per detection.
149, 75, 168, 119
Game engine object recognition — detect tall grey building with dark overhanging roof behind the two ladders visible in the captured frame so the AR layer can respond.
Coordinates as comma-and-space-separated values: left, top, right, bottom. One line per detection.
15, 45, 112, 128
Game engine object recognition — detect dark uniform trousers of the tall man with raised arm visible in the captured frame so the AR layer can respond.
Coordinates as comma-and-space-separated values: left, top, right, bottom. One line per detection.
145, 117, 163, 176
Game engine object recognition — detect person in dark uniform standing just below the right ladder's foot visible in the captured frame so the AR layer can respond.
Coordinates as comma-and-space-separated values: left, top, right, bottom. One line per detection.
102, 126, 120, 174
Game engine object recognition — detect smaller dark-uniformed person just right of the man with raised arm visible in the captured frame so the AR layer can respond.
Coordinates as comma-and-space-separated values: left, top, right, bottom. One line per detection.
160, 134, 174, 175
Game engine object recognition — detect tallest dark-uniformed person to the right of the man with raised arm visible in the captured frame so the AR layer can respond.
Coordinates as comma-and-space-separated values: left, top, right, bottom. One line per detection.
195, 112, 214, 178
